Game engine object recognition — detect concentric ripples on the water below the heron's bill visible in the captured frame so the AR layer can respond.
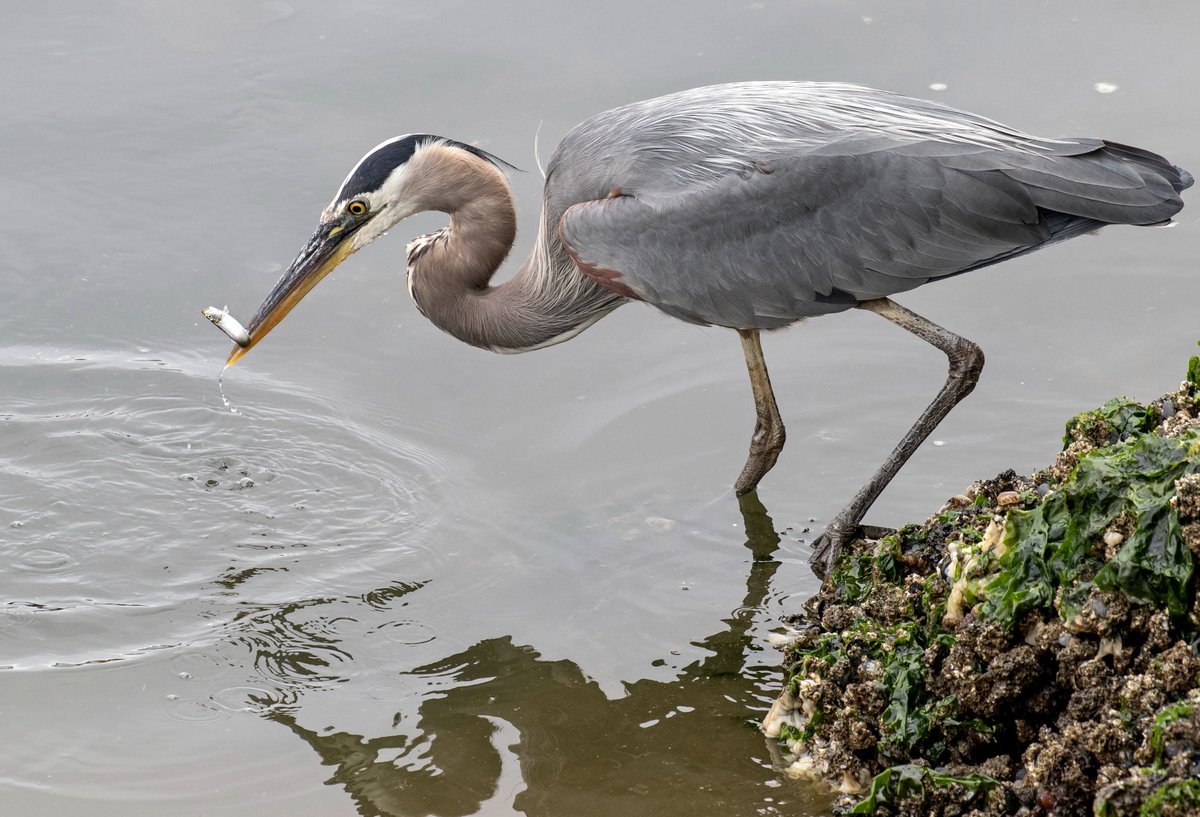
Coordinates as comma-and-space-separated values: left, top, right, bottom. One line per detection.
0, 347, 445, 674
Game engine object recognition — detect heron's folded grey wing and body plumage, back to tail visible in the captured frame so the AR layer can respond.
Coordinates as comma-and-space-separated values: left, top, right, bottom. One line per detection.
551, 84, 1188, 329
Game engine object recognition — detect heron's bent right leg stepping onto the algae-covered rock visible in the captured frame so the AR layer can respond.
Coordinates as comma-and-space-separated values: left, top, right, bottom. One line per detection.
810, 298, 983, 567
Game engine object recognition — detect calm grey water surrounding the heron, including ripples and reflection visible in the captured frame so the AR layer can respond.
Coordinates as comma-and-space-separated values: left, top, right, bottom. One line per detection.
0, 0, 1200, 817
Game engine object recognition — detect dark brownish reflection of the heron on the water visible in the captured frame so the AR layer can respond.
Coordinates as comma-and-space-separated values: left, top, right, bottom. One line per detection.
261, 494, 828, 817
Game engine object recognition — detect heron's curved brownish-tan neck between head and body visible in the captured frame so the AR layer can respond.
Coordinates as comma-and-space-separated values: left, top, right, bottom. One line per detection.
408, 145, 624, 353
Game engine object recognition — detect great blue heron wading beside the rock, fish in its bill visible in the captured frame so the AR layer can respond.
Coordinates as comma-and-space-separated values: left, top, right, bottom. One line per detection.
228, 82, 1193, 563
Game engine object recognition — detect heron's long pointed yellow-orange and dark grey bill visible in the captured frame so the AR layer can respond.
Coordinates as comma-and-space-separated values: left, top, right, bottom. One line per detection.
226, 220, 364, 366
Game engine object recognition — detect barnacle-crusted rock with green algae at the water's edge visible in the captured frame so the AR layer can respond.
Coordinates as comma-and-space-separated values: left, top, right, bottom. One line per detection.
764, 359, 1200, 817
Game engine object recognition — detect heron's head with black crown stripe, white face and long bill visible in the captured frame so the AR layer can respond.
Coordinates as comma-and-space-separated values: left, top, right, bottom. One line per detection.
226, 133, 502, 365
